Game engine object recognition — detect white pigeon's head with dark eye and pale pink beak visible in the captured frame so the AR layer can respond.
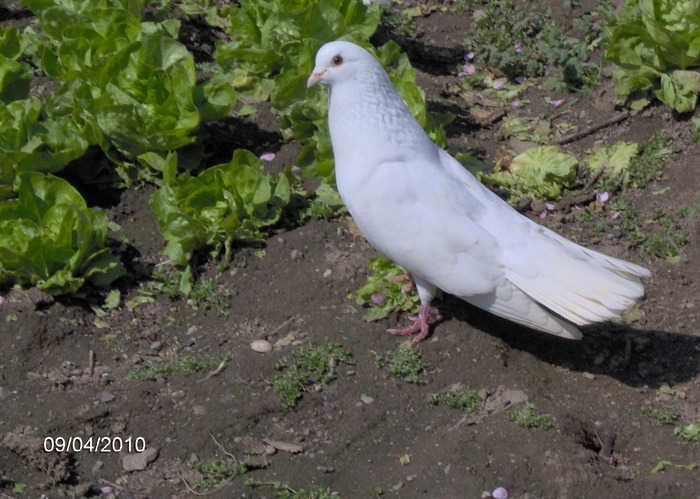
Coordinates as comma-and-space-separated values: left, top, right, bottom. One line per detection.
306, 41, 375, 87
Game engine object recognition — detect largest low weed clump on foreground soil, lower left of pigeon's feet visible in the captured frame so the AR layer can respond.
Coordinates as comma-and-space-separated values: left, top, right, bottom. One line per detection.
269, 342, 354, 407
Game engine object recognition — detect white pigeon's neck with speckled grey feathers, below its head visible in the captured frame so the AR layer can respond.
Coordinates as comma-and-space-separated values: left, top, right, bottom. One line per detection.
328, 67, 434, 168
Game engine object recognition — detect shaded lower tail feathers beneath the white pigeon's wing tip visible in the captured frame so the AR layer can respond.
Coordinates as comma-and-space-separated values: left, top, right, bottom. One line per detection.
461, 280, 581, 340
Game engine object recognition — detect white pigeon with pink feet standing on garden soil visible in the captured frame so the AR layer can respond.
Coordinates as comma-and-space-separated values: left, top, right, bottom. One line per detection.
307, 41, 651, 342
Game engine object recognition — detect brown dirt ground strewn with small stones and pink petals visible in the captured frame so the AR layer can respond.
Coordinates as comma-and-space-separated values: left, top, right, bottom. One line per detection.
0, 1, 700, 499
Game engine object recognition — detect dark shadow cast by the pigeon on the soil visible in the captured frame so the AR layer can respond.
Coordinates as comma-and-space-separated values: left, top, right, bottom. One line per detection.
437, 295, 700, 388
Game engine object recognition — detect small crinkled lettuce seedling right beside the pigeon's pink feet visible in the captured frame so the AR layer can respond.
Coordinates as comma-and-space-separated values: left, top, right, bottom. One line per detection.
348, 257, 420, 321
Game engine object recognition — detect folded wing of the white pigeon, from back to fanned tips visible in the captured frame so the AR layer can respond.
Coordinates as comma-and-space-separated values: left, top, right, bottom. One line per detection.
441, 148, 649, 325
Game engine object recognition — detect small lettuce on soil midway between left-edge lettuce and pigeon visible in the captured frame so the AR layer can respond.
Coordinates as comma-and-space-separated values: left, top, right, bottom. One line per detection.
150, 149, 294, 265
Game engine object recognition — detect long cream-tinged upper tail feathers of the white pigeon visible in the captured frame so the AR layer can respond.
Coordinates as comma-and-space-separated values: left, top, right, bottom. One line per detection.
506, 241, 649, 326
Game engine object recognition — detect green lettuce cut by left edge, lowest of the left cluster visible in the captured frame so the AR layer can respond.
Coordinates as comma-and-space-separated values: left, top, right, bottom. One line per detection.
0, 172, 124, 295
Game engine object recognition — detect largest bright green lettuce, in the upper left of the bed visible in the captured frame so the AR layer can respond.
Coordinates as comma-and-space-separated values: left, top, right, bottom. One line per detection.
24, 0, 235, 168
